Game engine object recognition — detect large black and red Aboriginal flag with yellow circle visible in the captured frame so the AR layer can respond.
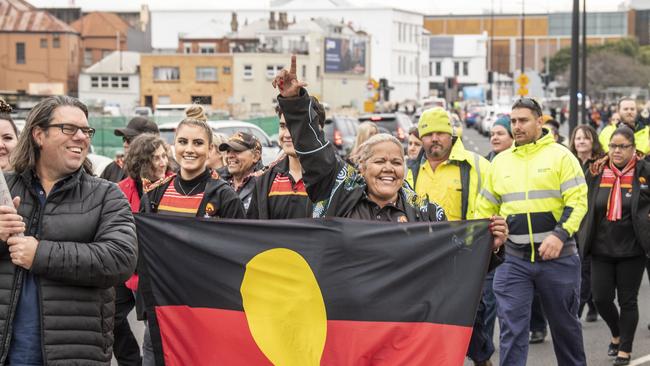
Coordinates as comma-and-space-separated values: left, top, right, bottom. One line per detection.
136, 215, 491, 366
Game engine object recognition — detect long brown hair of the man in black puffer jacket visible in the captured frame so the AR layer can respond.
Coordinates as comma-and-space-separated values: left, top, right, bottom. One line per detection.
11, 95, 93, 174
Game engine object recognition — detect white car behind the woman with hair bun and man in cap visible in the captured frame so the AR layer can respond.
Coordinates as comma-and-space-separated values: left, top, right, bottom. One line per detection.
158, 120, 281, 165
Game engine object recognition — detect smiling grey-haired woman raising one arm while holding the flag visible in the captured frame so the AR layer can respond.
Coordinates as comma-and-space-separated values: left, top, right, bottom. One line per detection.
273, 56, 507, 248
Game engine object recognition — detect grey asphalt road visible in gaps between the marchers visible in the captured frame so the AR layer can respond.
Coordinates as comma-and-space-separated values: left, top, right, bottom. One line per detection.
113, 124, 650, 366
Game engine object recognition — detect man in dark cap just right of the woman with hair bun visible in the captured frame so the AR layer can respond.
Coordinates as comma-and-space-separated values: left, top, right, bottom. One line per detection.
219, 132, 263, 211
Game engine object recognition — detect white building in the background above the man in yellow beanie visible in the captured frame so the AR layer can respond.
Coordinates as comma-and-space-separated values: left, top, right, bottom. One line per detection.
427, 34, 488, 99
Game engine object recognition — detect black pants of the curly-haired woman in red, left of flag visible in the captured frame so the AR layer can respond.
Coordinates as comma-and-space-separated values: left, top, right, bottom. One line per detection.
113, 284, 142, 366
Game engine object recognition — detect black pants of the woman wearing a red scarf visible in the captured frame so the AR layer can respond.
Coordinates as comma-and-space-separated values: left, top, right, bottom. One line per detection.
591, 256, 646, 352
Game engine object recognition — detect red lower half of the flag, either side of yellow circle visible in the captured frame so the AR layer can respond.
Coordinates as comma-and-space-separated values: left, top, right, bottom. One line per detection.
156, 306, 472, 366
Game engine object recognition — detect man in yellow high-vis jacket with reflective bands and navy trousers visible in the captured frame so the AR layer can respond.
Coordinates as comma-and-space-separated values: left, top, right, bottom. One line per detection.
477, 98, 587, 366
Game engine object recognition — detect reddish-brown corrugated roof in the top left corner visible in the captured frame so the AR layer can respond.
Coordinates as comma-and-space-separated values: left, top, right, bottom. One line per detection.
0, 0, 77, 33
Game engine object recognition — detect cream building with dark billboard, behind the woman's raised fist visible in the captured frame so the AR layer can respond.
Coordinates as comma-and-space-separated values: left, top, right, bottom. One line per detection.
228, 18, 369, 115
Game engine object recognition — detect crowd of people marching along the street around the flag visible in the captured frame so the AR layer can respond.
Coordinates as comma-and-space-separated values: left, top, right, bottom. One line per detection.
0, 57, 650, 366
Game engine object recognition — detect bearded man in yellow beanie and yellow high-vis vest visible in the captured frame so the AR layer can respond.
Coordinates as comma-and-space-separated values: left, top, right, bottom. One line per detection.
406, 107, 494, 365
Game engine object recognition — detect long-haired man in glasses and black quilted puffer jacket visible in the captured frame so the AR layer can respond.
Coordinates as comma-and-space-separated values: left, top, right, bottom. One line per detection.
0, 96, 137, 365
